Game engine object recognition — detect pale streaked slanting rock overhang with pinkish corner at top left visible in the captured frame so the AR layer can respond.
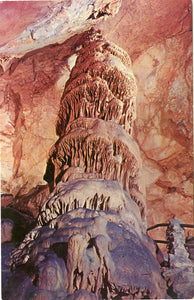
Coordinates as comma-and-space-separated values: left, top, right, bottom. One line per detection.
0, 0, 121, 71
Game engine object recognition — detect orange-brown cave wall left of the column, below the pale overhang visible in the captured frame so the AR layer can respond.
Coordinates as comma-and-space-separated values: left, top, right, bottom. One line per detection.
0, 40, 74, 197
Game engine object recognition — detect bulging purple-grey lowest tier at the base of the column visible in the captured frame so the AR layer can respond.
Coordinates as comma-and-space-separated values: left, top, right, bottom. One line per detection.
9, 208, 165, 299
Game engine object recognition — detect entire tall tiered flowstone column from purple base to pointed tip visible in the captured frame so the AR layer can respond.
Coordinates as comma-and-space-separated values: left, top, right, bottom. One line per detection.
6, 32, 165, 300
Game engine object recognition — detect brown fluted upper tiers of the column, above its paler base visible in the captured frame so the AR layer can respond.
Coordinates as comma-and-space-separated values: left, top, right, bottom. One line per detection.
44, 30, 146, 228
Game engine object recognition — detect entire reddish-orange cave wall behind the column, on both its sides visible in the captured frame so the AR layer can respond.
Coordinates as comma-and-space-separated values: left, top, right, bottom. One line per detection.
0, 0, 193, 241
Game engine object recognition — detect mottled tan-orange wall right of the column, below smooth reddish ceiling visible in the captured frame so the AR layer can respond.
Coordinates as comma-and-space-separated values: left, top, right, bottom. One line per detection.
133, 32, 193, 244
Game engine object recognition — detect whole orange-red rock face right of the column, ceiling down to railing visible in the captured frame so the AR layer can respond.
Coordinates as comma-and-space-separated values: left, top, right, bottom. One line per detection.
98, 0, 193, 246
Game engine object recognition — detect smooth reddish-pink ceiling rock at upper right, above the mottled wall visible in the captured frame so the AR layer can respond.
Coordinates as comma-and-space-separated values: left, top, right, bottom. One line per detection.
97, 0, 192, 61
